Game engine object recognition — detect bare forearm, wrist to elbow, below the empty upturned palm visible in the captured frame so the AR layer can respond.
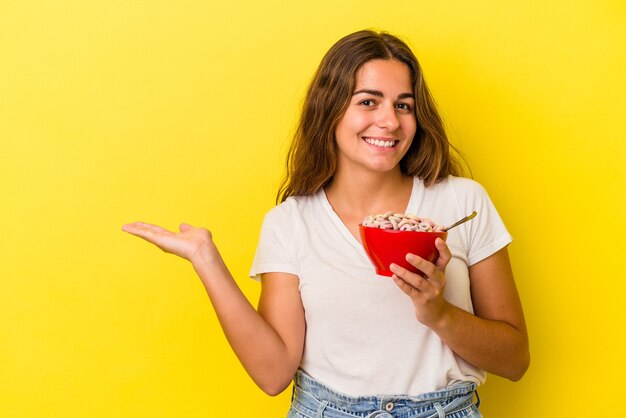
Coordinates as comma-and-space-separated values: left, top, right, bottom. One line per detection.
193, 250, 299, 395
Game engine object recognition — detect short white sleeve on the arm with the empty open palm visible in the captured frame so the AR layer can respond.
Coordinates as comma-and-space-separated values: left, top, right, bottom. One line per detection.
250, 202, 298, 280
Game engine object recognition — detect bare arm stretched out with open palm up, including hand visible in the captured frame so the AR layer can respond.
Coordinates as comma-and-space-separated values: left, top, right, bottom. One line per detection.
123, 223, 304, 395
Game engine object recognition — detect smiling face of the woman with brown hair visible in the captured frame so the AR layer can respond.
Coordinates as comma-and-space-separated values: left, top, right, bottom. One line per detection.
335, 59, 417, 172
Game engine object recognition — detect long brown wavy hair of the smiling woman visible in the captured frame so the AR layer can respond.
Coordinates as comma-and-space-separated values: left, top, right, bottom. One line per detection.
276, 30, 463, 203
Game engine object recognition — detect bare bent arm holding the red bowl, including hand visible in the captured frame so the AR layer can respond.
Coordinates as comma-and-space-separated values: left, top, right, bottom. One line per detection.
392, 240, 530, 381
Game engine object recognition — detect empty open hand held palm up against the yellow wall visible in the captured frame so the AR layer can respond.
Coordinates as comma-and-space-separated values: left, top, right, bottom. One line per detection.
122, 222, 215, 263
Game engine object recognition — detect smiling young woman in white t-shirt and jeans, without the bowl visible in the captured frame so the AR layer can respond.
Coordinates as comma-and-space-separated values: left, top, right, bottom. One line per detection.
123, 31, 529, 418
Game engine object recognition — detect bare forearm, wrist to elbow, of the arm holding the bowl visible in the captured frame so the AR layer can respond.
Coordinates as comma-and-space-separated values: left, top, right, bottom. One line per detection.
431, 304, 530, 381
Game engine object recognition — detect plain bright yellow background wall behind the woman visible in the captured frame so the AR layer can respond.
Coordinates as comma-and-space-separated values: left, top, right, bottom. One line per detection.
0, 0, 626, 418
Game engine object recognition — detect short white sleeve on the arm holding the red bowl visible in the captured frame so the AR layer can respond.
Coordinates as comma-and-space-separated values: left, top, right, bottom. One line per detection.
455, 179, 512, 266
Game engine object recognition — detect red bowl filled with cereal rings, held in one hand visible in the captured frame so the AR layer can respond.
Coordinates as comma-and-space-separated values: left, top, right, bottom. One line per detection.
359, 225, 448, 277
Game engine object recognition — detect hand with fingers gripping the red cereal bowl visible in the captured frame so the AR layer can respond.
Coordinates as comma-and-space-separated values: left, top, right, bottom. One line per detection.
390, 238, 452, 328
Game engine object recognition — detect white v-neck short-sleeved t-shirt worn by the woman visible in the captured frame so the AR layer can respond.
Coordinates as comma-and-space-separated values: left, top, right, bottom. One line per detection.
250, 176, 511, 396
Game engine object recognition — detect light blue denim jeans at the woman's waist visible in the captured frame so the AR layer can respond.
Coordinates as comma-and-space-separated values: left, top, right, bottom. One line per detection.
287, 371, 482, 418
